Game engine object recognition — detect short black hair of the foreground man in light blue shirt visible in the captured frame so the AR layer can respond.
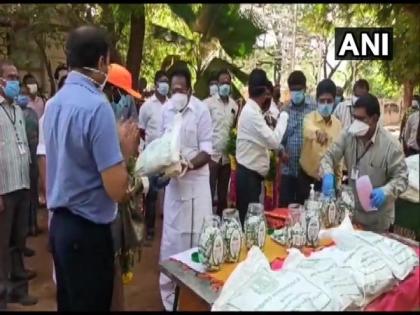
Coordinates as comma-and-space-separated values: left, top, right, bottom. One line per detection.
66, 26, 110, 68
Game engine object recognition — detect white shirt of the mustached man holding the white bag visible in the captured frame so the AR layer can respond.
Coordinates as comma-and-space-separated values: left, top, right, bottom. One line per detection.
161, 96, 213, 179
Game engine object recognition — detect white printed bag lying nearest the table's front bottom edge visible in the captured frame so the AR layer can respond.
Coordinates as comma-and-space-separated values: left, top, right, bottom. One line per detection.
212, 246, 344, 311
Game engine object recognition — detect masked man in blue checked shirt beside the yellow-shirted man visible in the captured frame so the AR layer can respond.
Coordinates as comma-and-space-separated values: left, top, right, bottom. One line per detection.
280, 71, 316, 207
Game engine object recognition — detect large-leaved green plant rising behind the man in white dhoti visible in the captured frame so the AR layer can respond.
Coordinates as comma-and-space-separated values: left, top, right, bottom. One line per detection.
148, 4, 263, 98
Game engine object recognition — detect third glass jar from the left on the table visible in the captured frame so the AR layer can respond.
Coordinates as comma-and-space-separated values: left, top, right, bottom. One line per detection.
245, 203, 267, 250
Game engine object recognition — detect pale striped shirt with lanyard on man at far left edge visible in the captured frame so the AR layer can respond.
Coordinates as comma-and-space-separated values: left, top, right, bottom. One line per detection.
0, 97, 30, 195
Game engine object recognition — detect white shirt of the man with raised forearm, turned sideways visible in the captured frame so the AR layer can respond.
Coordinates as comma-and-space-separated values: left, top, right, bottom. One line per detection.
236, 99, 289, 177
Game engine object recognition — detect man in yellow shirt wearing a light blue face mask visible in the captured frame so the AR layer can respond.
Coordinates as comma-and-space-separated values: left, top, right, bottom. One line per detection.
298, 79, 341, 204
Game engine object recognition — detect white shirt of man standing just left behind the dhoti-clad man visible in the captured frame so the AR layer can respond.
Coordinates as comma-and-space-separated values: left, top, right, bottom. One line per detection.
139, 94, 166, 146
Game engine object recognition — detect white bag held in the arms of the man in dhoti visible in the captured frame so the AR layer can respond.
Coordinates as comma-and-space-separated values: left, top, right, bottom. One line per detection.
135, 113, 182, 176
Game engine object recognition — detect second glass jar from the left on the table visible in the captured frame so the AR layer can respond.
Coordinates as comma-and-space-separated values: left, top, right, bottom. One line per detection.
222, 209, 243, 263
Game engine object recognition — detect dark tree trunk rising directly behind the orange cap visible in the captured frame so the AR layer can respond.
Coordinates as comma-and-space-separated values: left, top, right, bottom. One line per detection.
127, 4, 146, 90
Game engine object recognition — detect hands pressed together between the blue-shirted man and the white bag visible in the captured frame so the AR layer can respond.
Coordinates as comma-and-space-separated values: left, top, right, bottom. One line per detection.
118, 119, 140, 161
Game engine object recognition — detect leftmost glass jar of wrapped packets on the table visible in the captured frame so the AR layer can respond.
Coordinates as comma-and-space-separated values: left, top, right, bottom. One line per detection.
198, 215, 224, 271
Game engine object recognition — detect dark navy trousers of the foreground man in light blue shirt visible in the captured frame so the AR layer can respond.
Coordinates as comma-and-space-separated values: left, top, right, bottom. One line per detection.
50, 208, 114, 311
